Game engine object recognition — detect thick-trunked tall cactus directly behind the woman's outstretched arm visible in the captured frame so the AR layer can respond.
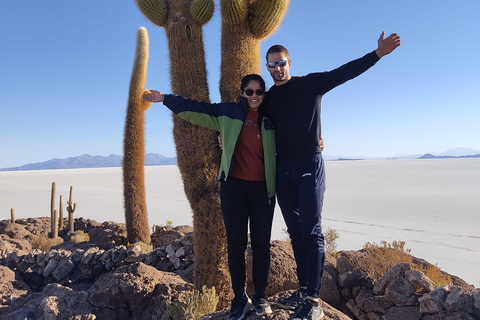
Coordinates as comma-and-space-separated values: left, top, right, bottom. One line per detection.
136, 0, 230, 305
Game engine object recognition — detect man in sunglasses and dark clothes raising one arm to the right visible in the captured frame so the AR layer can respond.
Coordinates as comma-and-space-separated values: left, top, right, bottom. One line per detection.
264, 32, 400, 320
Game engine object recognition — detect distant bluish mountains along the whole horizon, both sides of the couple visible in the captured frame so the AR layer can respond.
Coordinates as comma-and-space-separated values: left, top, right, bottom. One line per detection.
0, 148, 480, 171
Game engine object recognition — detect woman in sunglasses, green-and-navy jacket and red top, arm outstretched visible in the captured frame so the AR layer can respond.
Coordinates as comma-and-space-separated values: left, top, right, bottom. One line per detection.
143, 74, 275, 320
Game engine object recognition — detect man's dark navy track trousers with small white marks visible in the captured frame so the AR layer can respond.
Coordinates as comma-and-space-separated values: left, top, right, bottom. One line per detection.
276, 153, 325, 297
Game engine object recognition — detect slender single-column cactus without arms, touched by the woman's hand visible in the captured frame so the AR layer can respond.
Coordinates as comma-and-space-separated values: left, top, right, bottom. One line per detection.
123, 27, 151, 243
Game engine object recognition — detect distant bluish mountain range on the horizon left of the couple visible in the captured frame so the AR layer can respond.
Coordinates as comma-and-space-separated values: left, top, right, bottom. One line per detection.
0, 153, 177, 171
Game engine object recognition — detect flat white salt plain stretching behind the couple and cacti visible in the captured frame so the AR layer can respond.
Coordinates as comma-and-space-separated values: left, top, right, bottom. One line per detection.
0, 159, 480, 287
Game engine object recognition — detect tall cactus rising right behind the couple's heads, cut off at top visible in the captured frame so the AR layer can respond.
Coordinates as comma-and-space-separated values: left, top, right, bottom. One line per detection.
220, 0, 290, 101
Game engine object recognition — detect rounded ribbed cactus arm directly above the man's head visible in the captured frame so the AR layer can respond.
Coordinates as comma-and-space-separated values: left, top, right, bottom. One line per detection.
249, 0, 290, 40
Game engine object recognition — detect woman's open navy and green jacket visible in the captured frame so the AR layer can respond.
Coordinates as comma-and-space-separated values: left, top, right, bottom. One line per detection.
163, 94, 276, 198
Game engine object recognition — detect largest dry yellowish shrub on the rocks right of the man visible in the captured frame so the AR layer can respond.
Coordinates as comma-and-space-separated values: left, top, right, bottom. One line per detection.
363, 241, 413, 280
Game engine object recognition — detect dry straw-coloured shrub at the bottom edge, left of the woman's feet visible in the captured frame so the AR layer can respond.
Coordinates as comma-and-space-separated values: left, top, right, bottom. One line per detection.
167, 286, 218, 320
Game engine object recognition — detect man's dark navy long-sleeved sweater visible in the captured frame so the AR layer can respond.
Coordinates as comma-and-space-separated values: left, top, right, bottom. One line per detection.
263, 51, 379, 159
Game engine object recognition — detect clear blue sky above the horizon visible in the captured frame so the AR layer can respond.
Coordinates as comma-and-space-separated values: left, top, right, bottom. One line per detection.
0, 0, 480, 168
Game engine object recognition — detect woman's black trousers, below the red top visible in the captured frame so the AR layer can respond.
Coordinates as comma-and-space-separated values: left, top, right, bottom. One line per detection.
221, 177, 275, 297
